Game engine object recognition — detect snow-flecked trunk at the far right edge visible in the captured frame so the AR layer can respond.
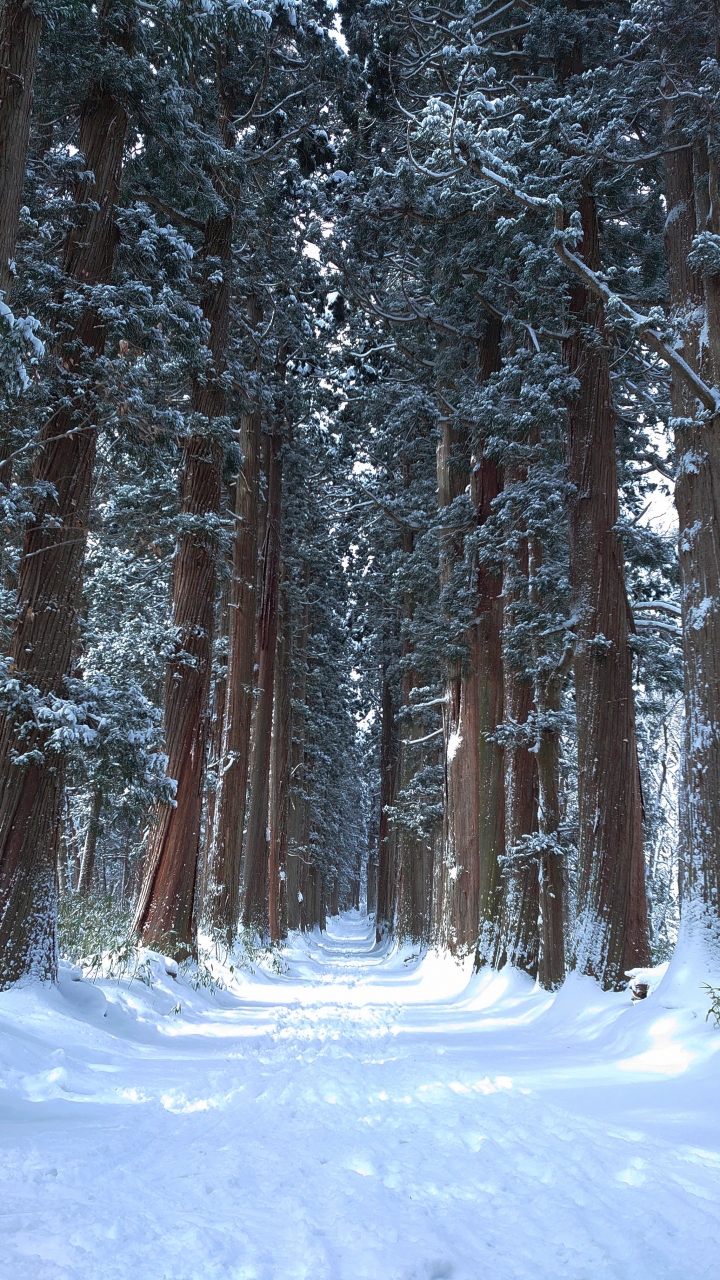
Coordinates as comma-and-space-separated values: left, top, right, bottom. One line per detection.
664, 124, 720, 919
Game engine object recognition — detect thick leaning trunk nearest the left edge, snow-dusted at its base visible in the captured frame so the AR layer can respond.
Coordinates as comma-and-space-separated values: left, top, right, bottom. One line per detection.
0, 15, 129, 988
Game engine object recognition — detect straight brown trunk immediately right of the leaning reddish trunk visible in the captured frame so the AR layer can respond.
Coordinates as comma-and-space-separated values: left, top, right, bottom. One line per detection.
209, 297, 263, 941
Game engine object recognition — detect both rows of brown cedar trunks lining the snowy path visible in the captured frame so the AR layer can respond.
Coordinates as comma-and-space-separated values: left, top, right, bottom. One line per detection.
0, 0, 720, 987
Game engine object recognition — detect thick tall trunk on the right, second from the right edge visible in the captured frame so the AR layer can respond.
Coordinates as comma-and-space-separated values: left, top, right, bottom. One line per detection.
564, 195, 650, 987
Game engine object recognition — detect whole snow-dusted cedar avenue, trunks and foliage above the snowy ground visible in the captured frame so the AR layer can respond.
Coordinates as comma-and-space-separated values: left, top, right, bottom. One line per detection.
0, 0, 720, 989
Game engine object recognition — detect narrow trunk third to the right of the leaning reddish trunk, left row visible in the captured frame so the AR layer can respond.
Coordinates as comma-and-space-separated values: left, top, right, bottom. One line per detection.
268, 575, 292, 942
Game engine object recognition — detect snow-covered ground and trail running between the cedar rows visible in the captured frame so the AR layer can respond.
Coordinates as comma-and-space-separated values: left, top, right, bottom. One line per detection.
0, 914, 720, 1280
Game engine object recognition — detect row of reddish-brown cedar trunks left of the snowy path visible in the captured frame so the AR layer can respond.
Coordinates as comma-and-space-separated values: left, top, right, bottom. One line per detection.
0, 0, 359, 987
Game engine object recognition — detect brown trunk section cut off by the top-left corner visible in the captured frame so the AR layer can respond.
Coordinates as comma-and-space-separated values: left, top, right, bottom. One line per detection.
0, 0, 42, 301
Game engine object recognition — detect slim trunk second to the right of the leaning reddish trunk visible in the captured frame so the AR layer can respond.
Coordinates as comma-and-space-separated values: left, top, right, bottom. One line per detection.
242, 429, 282, 937
